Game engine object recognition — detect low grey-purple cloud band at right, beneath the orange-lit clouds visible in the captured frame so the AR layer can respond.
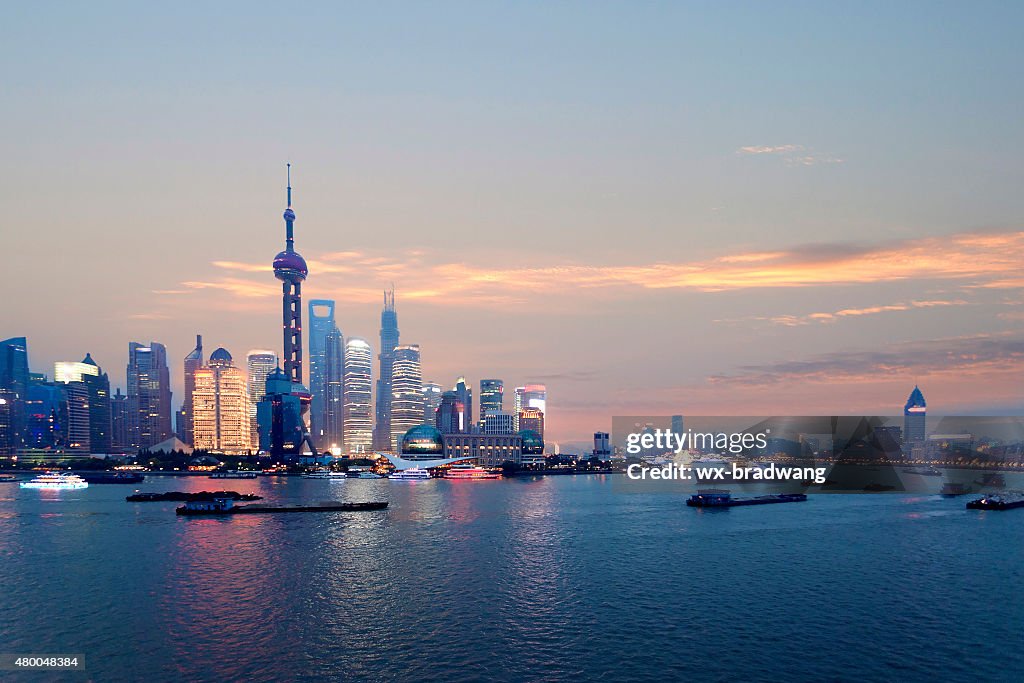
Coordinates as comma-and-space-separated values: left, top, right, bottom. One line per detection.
709, 334, 1024, 386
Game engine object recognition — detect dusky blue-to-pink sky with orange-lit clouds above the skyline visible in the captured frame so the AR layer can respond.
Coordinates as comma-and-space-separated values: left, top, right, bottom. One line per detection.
0, 2, 1024, 443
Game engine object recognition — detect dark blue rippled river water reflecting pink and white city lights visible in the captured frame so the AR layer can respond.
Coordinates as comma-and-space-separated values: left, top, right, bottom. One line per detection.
0, 476, 1024, 682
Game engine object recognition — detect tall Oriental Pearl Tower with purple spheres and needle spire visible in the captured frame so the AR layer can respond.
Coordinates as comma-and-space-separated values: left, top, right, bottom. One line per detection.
273, 164, 316, 456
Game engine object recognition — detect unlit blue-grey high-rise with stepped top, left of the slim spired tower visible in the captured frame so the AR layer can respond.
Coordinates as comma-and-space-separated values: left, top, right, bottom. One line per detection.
128, 342, 171, 449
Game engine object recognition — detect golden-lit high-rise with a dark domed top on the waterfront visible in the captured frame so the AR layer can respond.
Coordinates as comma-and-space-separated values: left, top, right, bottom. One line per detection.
193, 348, 252, 455
